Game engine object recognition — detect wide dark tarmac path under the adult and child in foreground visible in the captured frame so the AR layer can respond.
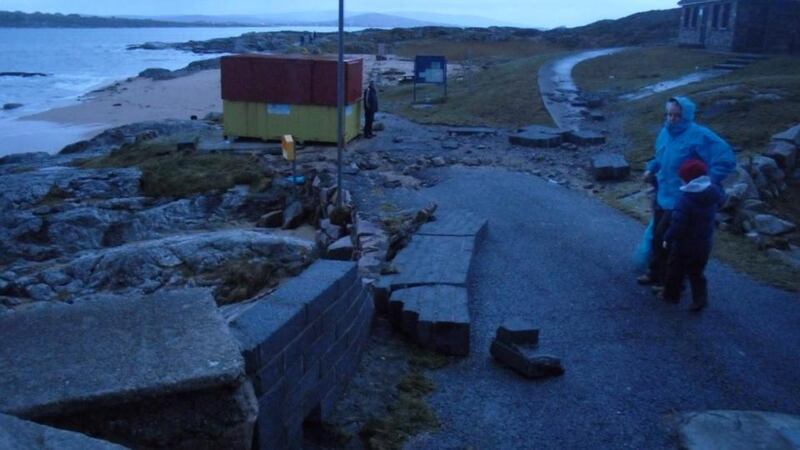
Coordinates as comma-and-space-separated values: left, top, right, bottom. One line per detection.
407, 168, 800, 450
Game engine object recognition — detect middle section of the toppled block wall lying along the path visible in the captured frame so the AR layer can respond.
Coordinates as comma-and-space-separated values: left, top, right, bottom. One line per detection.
389, 236, 475, 290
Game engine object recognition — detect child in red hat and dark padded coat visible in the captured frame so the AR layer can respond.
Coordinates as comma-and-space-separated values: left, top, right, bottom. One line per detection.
662, 159, 725, 311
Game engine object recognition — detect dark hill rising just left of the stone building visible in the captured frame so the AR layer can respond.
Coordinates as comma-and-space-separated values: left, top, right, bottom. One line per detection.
544, 8, 681, 48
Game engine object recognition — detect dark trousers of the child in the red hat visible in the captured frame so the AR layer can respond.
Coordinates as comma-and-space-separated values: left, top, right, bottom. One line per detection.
664, 248, 710, 303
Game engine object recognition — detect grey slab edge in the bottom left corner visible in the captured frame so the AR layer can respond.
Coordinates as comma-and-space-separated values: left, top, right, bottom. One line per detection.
0, 414, 127, 450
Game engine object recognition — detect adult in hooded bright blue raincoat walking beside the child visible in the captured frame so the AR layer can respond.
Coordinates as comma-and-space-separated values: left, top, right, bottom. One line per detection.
637, 97, 736, 285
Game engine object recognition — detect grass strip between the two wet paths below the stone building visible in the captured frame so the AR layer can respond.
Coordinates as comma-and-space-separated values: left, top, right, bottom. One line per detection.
572, 47, 728, 94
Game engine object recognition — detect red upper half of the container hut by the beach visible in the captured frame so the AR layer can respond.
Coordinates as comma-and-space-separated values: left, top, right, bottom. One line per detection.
221, 54, 363, 106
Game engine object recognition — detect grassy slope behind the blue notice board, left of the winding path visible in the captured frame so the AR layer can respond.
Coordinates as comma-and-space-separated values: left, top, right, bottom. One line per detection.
382, 53, 555, 127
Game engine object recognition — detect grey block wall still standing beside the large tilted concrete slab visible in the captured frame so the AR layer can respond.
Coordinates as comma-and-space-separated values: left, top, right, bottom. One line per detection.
222, 260, 374, 449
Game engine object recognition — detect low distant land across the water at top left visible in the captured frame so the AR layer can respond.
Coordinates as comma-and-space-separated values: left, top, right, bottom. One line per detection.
0, 11, 253, 28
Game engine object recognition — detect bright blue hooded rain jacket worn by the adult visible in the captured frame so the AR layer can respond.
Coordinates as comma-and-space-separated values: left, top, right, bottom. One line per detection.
647, 97, 736, 209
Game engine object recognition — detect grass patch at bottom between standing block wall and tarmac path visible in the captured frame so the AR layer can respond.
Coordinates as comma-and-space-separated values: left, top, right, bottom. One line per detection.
359, 348, 452, 450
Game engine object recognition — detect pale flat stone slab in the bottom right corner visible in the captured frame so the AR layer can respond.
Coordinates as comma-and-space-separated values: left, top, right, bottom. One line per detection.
678, 410, 800, 450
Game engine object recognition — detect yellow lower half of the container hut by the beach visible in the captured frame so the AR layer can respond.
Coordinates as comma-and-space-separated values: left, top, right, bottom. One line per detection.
222, 100, 361, 144
